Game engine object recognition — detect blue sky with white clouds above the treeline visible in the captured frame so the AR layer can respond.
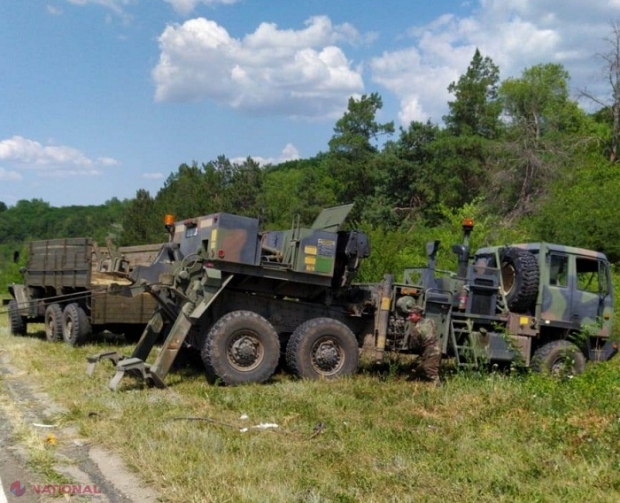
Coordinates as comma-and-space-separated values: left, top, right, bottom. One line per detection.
0, 0, 620, 207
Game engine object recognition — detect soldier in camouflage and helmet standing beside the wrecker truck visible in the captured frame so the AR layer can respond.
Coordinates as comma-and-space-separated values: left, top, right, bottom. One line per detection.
407, 306, 441, 385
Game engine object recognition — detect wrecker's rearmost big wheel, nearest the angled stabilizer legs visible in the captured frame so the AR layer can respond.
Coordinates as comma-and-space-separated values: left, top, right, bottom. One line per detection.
201, 311, 280, 385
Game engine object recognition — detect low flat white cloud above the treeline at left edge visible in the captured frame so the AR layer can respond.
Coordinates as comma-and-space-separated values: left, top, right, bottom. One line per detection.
0, 136, 118, 176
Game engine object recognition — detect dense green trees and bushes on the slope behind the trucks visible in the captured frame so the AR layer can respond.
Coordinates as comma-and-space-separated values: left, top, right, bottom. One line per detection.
0, 46, 620, 288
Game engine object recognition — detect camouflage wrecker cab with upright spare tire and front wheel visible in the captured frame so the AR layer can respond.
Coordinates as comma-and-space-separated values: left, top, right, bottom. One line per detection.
446, 242, 617, 372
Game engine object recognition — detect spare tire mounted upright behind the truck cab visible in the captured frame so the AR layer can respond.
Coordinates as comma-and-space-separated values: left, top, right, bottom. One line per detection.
501, 248, 540, 313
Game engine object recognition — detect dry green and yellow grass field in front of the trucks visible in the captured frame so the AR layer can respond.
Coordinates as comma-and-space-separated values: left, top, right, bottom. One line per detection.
0, 314, 620, 503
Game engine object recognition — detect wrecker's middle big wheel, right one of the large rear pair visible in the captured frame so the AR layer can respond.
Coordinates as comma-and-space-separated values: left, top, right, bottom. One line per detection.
286, 318, 359, 379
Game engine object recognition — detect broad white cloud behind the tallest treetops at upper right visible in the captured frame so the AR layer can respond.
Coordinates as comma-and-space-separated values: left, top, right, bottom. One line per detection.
369, 0, 620, 125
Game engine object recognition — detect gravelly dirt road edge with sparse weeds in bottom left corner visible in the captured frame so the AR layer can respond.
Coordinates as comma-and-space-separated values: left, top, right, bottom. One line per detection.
0, 350, 157, 503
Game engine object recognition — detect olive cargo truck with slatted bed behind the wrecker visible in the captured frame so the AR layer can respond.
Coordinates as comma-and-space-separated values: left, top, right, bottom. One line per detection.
8, 237, 162, 345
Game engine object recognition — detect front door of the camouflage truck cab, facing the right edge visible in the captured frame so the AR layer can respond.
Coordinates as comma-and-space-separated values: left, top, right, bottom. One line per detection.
571, 257, 613, 332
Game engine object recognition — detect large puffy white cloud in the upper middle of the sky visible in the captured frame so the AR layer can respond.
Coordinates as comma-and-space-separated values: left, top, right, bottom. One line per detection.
152, 16, 364, 118
